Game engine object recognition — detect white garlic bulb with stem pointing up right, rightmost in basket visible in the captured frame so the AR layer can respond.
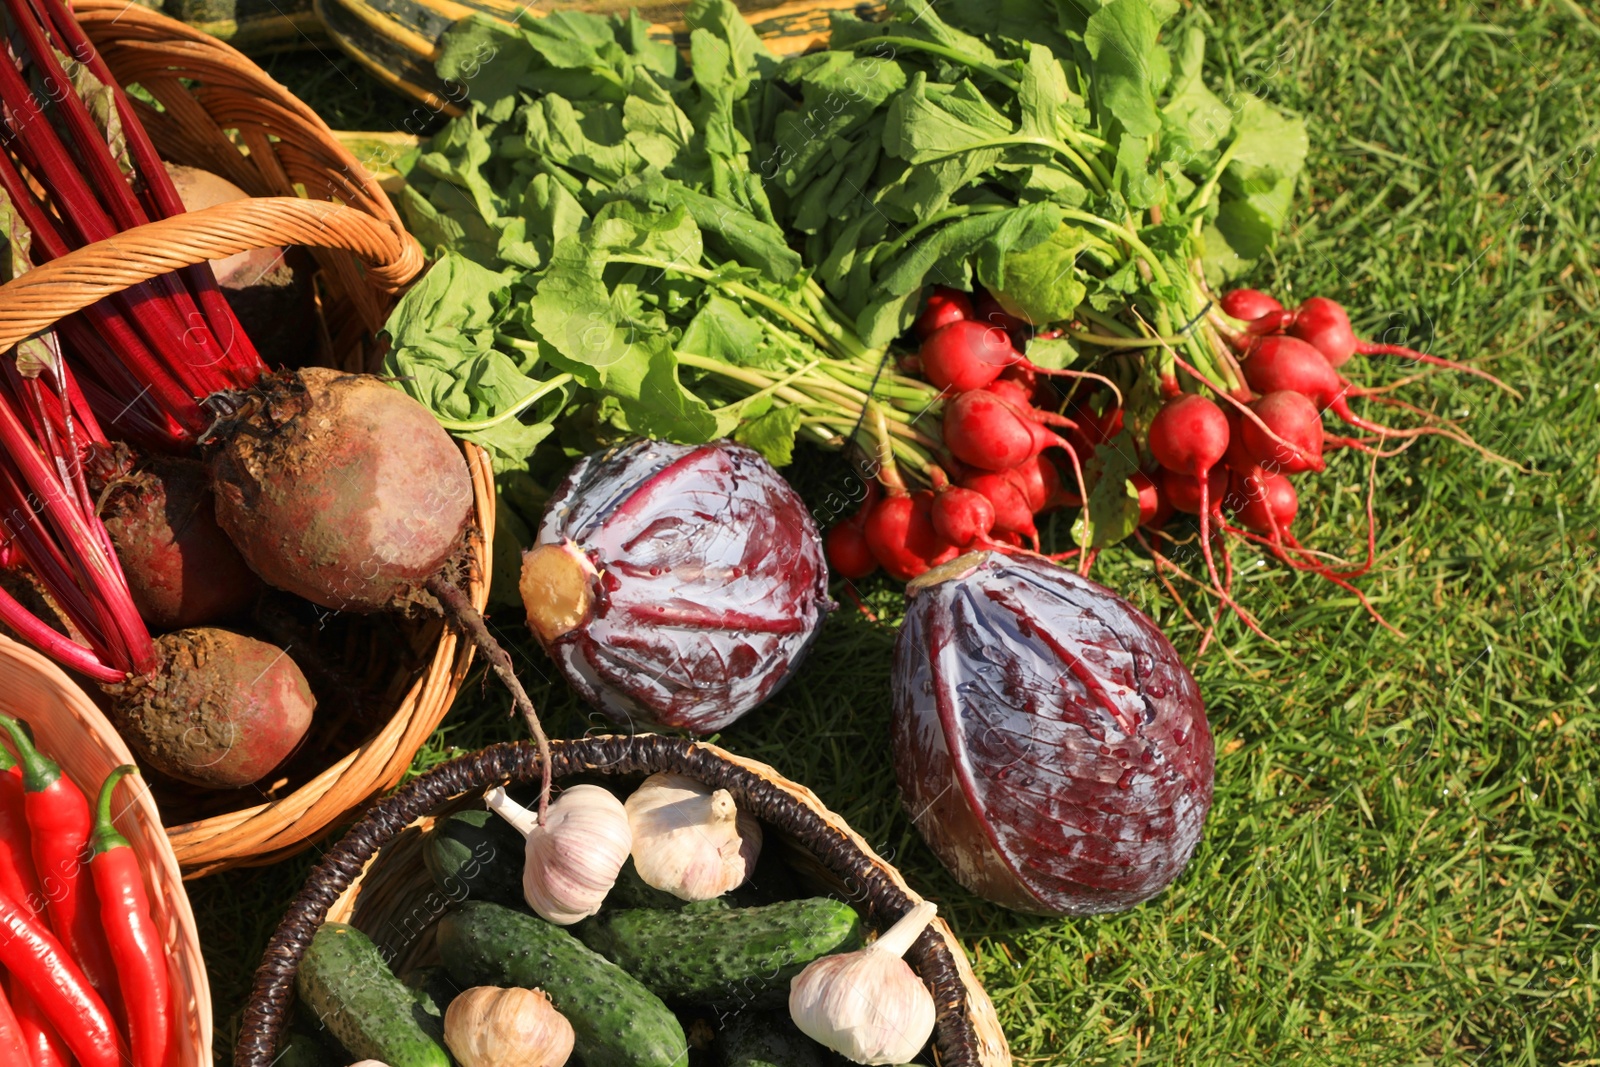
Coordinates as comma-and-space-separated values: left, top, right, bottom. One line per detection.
789, 901, 938, 1064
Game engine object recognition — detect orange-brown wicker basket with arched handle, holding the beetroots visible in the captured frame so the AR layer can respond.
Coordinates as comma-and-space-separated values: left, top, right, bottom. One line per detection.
0, 0, 494, 877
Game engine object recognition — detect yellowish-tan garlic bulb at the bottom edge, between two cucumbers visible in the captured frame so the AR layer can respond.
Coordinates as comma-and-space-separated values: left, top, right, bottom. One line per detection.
445, 985, 574, 1067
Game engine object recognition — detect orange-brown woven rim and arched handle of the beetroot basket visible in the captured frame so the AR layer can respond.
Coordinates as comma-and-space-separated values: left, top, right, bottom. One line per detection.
0, 0, 480, 877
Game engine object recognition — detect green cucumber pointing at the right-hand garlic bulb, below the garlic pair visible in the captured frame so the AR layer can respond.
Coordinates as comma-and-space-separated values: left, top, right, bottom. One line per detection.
578, 897, 861, 1008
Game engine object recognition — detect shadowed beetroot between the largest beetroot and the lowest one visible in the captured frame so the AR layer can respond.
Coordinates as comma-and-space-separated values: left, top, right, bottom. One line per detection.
101, 456, 262, 630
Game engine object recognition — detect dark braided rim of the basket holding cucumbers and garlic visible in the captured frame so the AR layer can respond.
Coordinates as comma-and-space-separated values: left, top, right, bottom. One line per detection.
234, 734, 1011, 1067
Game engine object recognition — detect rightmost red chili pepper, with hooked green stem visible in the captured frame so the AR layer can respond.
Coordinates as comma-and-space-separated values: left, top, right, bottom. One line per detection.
90, 766, 173, 1067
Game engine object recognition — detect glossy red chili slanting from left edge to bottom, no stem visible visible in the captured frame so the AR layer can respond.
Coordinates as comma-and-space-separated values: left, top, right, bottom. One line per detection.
0, 894, 123, 1067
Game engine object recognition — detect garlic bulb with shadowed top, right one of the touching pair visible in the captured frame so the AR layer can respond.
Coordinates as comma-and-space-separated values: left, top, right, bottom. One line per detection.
626, 774, 762, 901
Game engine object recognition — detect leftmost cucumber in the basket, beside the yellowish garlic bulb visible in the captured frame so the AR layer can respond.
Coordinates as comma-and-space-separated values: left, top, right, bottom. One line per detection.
294, 923, 450, 1067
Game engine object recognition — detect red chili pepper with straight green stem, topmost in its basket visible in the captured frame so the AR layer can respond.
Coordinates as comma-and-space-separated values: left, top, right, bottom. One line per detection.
0, 715, 122, 1017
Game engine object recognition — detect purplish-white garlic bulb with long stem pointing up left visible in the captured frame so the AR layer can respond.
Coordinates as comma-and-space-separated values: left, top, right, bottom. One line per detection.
483, 785, 634, 926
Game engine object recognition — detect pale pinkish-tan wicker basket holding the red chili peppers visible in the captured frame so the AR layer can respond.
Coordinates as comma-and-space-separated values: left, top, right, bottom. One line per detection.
0, 637, 211, 1067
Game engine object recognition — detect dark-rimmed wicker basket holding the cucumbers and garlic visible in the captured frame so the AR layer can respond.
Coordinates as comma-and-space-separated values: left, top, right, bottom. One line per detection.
234, 734, 1011, 1067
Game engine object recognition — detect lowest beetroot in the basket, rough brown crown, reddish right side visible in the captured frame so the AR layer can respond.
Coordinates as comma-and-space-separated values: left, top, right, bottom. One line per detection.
106, 629, 317, 789
